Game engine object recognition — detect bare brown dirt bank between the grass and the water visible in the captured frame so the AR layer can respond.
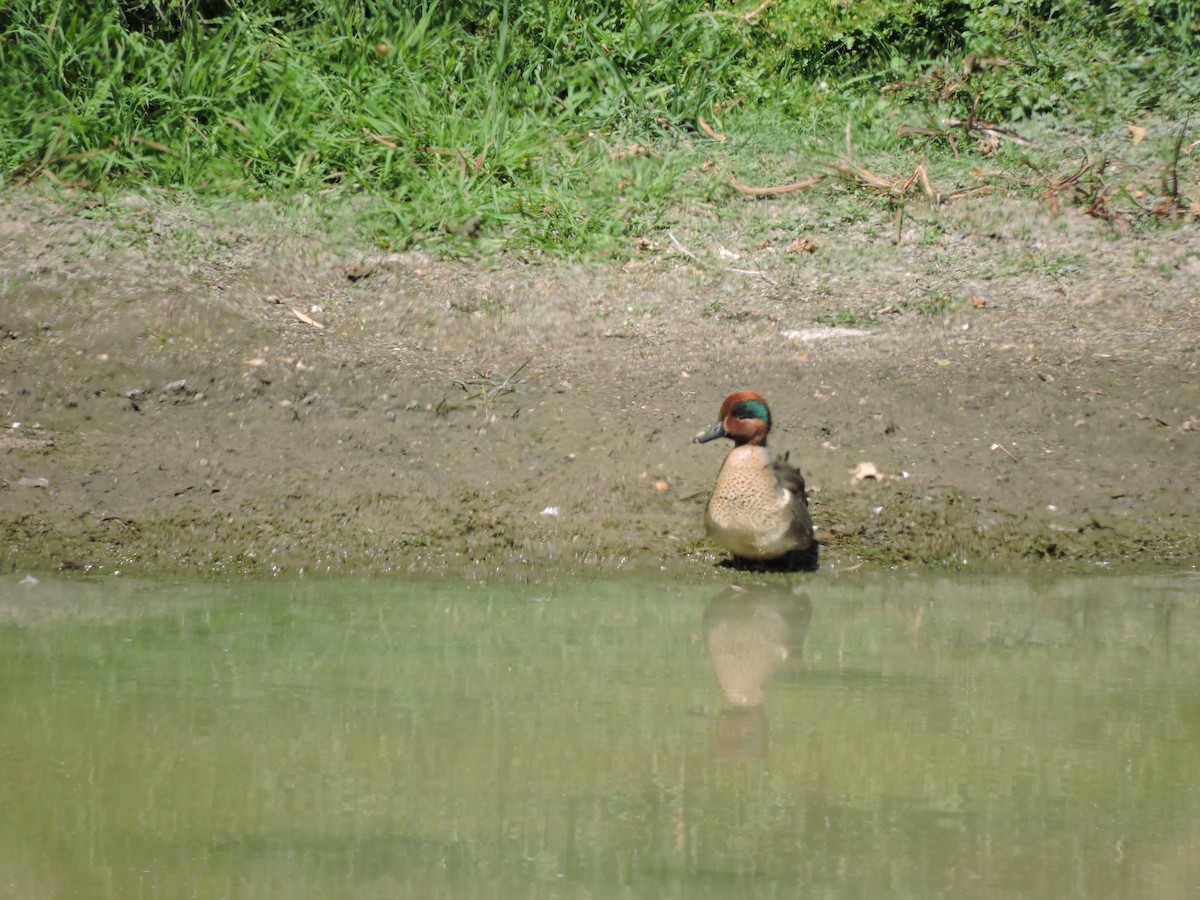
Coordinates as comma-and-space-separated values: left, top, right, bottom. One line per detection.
0, 193, 1200, 580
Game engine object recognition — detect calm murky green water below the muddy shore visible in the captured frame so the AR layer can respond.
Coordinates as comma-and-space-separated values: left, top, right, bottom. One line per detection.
0, 574, 1200, 900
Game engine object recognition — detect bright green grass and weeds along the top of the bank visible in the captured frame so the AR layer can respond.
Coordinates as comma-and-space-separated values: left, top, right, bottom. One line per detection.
0, 0, 1200, 253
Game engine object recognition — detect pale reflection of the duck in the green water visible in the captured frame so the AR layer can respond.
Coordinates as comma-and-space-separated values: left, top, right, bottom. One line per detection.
704, 586, 812, 760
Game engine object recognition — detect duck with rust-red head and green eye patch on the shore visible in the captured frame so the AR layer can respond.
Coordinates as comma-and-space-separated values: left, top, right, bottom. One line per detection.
692, 391, 814, 562
